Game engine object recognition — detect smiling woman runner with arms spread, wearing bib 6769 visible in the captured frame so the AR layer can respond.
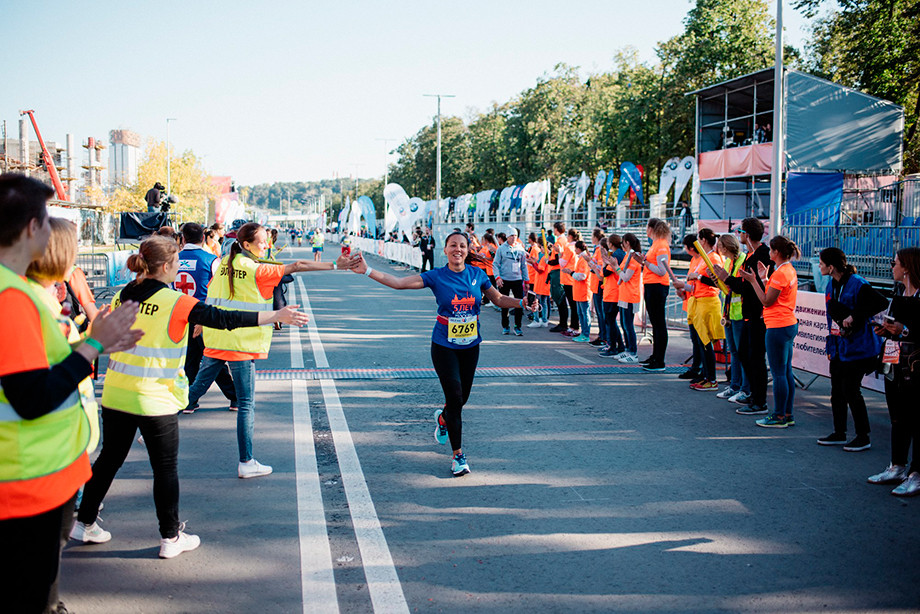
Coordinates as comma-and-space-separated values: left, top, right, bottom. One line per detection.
351, 231, 539, 477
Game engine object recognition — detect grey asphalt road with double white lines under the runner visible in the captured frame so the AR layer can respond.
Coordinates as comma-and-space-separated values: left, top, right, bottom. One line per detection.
61, 245, 920, 614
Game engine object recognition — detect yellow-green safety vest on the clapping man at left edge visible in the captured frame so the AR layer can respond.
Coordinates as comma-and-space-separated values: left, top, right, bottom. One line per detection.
0, 265, 90, 490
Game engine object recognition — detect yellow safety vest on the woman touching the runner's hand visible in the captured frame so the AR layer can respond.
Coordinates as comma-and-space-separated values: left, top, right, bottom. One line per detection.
203, 254, 273, 354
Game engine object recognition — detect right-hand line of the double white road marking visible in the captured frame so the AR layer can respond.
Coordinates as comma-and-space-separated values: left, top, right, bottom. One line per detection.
297, 277, 409, 614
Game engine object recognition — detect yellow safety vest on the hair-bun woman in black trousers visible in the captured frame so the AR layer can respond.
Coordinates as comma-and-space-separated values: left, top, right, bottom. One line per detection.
102, 288, 188, 416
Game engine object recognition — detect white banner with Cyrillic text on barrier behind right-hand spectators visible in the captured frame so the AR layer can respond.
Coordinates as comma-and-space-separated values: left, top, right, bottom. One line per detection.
792, 290, 885, 392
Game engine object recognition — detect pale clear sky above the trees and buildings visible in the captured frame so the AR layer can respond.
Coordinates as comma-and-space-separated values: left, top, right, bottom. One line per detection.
0, 0, 807, 185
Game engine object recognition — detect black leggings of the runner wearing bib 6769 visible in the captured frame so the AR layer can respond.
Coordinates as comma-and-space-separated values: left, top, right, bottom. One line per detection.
431, 343, 479, 450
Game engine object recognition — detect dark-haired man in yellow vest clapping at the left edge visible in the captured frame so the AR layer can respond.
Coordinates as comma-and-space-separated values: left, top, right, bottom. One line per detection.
0, 173, 140, 613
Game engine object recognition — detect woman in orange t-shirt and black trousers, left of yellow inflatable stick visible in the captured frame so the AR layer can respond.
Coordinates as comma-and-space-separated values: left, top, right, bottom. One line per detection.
636, 218, 671, 372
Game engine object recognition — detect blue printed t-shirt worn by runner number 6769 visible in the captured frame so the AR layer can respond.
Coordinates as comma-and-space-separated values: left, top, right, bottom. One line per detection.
422, 265, 492, 349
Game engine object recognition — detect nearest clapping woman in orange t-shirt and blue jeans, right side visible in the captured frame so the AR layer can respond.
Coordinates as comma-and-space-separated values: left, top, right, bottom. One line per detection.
739, 236, 801, 429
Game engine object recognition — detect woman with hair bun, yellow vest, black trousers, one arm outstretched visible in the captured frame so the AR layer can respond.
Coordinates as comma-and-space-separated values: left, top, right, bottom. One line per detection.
70, 236, 307, 559
